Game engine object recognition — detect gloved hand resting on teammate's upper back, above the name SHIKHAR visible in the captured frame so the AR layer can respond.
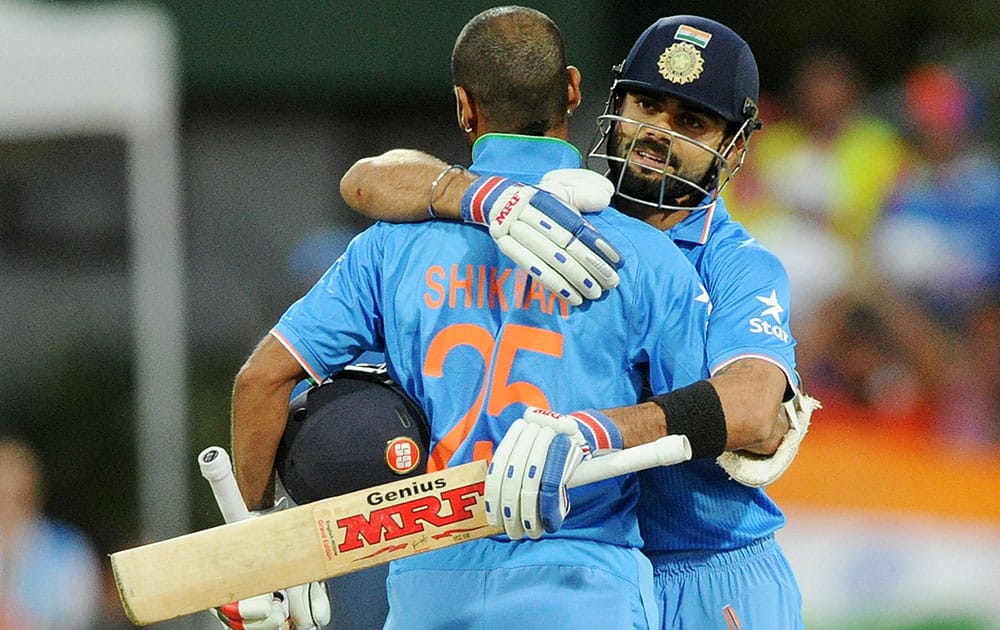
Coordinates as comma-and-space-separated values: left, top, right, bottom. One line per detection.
462, 169, 622, 306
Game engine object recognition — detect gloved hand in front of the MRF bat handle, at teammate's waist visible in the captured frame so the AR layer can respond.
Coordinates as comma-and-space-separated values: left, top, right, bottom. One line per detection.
483, 407, 622, 540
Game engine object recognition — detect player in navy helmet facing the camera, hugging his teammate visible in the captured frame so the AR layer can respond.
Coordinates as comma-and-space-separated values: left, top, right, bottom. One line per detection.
342, 15, 818, 630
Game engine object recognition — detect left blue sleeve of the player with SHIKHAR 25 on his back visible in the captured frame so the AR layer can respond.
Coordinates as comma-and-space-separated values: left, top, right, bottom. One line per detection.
271, 224, 385, 383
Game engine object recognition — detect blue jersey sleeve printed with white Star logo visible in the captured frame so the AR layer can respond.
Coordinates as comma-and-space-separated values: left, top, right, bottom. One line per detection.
702, 239, 798, 389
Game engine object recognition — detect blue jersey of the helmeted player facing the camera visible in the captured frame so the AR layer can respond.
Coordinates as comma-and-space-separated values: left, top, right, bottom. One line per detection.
640, 198, 798, 552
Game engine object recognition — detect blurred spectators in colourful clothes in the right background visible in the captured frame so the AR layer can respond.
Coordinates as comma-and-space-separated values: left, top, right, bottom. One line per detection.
724, 50, 1000, 449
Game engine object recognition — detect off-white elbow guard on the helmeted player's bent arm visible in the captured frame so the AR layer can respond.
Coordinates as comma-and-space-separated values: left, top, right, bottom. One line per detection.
716, 392, 823, 488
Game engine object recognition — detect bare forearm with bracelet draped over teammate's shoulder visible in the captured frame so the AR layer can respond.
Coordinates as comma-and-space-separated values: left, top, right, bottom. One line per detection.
340, 149, 475, 223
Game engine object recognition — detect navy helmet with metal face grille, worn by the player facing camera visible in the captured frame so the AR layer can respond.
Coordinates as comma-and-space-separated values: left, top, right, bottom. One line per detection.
587, 15, 761, 218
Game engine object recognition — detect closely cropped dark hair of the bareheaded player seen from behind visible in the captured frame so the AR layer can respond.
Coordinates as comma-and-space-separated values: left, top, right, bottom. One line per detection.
451, 6, 568, 136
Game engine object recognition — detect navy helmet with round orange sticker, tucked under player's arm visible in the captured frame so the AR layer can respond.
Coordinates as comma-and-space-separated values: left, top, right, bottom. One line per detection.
274, 365, 430, 505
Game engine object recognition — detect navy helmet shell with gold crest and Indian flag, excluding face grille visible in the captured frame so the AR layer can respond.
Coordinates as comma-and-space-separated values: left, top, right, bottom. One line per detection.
614, 15, 760, 129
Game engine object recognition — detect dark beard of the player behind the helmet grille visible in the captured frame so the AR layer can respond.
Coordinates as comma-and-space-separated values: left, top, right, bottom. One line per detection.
609, 128, 707, 205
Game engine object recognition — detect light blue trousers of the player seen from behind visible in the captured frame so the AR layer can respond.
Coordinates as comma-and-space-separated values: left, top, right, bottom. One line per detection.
385, 538, 658, 630
